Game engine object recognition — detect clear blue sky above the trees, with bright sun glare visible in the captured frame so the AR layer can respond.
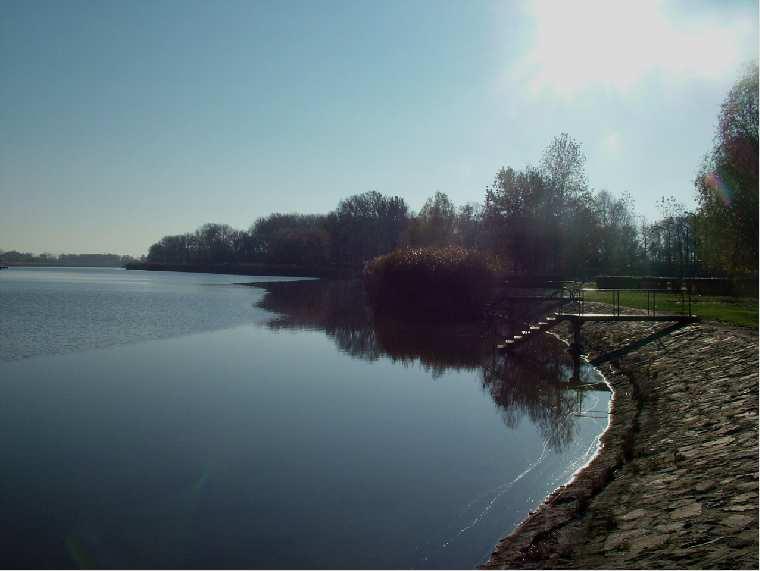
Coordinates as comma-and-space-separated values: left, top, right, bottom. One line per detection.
0, 0, 758, 256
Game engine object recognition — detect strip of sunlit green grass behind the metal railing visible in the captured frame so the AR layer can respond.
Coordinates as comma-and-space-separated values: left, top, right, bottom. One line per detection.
584, 291, 758, 328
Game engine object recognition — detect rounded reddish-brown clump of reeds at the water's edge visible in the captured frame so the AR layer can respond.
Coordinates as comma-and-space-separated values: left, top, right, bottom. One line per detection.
364, 246, 500, 321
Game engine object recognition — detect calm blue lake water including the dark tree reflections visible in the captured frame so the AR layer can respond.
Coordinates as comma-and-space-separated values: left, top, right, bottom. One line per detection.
0, 268, 609, 568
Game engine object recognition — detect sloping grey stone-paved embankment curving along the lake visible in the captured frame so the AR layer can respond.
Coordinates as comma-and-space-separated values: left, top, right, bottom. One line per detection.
484, 308, 758, 569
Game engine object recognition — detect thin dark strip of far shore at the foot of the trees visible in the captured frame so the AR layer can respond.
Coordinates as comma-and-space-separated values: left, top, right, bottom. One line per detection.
124, 262, 359, 278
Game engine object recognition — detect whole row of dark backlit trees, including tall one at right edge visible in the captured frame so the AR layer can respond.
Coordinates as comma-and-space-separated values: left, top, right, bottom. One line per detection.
147, 67, 758, 277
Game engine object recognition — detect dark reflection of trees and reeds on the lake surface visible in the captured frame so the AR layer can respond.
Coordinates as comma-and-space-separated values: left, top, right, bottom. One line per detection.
252, 280, 600, 451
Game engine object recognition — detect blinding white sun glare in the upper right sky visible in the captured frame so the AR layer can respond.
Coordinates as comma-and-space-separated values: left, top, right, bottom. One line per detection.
513, 0, 751, 97
